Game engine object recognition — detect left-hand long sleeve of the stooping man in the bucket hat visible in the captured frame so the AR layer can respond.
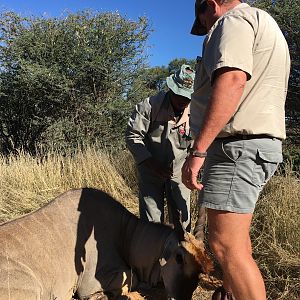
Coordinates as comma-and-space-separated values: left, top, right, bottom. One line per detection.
125, 98, 152, 164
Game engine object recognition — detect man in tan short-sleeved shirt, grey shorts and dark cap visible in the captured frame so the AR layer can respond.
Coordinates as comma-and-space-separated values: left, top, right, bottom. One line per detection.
182, 0, 290, 300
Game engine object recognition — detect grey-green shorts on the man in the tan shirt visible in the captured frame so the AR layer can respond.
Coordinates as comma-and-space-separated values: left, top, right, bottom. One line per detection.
199, 138, 282, 213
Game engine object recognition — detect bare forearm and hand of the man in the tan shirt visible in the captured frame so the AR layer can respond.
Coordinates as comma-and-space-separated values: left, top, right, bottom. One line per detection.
182, 68, 247, 189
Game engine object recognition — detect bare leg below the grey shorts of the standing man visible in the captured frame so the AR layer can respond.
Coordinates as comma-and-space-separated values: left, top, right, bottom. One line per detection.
207, 209, 266, 300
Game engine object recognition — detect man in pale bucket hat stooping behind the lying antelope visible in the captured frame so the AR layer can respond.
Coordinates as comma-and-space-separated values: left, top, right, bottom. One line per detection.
126, 65, 195, 232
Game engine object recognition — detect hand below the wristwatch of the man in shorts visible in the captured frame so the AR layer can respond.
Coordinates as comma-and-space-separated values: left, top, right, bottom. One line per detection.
181, 156, 205, 190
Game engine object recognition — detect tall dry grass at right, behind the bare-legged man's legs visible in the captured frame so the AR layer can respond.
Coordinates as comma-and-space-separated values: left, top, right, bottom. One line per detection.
252, 165, 300, 300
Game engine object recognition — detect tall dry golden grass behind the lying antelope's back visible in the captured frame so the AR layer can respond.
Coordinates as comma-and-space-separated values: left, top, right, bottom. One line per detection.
0, 147, 137, 221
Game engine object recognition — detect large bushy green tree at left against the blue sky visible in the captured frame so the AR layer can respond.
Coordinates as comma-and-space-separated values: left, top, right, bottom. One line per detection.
0, 11, 149, 153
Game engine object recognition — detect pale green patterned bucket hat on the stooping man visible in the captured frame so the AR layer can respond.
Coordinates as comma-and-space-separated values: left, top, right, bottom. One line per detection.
166, 65, 195, 99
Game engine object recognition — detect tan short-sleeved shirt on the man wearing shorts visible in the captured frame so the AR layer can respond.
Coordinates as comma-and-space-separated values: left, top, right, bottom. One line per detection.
190, 3, 290, 139
